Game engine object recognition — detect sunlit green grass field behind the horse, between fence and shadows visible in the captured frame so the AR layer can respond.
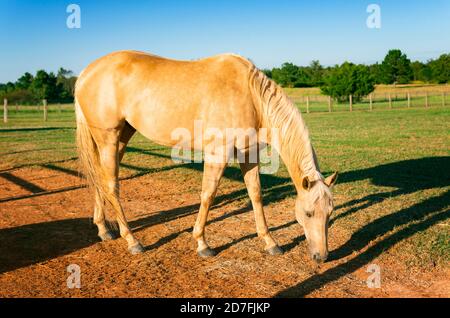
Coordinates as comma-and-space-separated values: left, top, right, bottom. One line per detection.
0, 105, 450, 170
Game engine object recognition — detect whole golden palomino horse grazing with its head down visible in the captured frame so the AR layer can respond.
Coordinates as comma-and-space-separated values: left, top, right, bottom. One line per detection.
75, 51, 337, 261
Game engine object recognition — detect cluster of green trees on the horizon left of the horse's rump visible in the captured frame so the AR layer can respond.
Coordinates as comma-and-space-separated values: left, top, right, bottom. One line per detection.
0, 67, 77, 105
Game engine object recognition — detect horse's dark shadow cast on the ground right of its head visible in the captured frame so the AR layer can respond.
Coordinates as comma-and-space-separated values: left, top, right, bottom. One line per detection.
330, 157, 450, 259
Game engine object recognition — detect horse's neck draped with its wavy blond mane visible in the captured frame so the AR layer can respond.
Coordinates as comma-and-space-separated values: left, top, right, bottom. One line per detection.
244, 62, 322, 184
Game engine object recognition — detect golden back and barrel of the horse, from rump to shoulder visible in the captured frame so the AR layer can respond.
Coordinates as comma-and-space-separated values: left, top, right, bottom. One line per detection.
75, 51, 257, 144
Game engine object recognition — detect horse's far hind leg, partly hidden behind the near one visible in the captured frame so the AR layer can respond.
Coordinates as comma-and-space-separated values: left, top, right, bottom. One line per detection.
94, 123, 136, 241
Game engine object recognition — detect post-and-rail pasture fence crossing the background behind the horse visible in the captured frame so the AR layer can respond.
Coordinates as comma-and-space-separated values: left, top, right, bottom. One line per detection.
2, 90, 450, 124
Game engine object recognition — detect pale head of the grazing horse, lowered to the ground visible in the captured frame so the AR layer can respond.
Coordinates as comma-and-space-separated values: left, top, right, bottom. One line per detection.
295, 172, 337, 263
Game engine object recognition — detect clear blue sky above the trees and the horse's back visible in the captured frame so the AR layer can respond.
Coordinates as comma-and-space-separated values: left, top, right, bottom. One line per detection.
0, 0, 450, 82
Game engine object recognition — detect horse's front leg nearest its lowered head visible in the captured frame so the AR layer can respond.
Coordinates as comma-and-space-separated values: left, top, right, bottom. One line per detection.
240, 163, 283, 255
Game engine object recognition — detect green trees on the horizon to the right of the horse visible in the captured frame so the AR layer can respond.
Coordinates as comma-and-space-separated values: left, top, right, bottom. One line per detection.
264, 49, 450, 101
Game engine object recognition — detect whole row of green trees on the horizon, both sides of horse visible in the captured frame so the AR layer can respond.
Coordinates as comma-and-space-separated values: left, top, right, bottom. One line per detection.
0, 49, 450, 104
